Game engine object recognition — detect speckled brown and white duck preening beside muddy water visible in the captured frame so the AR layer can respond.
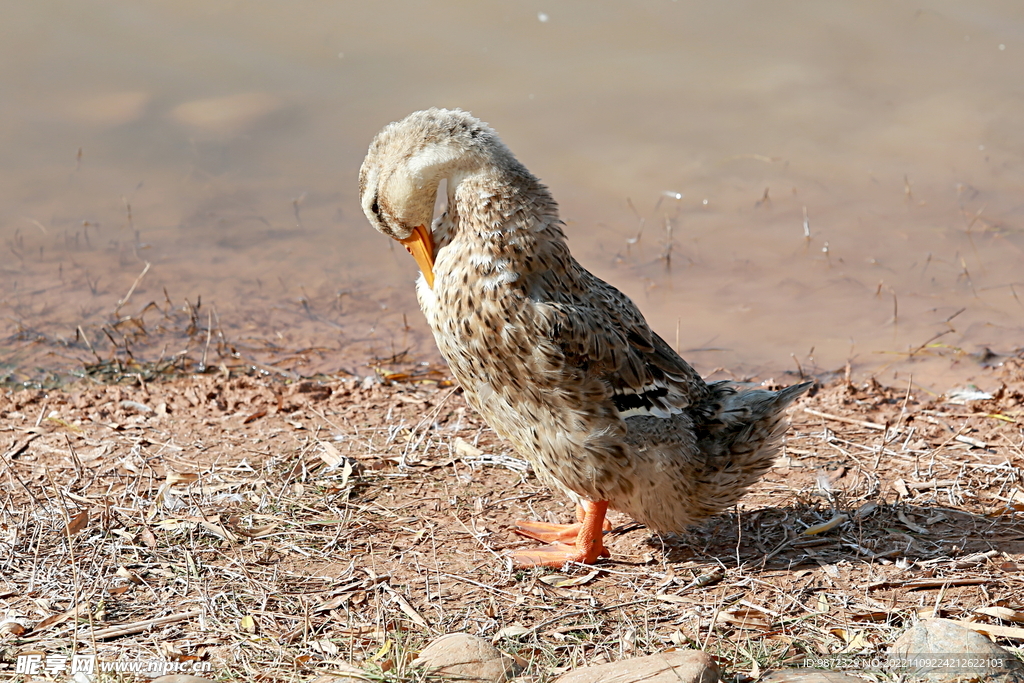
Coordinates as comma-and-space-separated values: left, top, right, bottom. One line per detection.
358, 109, 812, 567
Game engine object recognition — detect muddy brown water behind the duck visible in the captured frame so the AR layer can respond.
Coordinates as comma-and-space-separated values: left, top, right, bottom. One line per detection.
0, 0, 1024, 389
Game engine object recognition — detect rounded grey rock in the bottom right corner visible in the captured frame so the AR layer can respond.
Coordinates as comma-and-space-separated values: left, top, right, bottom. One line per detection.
889, 618, 1024, 683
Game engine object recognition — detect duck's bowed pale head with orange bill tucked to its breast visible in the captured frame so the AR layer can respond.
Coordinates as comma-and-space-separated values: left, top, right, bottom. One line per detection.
359, 109, 514, 287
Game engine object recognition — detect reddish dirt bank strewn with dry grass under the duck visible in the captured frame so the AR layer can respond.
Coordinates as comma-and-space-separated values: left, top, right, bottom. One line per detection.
0, 361, 1024, 682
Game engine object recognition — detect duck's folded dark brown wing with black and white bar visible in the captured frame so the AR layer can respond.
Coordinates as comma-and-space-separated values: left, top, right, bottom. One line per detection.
544, 262, 709, 419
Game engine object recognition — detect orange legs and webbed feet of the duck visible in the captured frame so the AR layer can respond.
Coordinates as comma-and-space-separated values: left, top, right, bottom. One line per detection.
512, 501, 610, 567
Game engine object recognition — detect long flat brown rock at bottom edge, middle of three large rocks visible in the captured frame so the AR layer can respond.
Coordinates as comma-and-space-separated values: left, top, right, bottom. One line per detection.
555, 650, 718, 683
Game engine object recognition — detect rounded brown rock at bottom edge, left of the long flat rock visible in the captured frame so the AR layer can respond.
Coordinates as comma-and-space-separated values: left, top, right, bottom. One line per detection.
413, 633, 519, 683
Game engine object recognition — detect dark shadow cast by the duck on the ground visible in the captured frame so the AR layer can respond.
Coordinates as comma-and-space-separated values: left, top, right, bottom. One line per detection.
634, 503, 1024, 570
